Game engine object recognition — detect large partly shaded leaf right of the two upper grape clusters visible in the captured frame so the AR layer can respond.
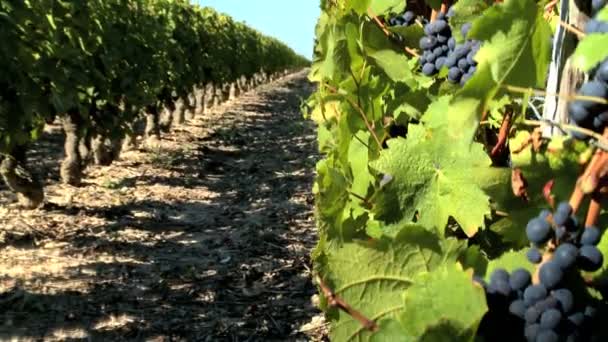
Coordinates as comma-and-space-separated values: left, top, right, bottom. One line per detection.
449, 0, 551, 139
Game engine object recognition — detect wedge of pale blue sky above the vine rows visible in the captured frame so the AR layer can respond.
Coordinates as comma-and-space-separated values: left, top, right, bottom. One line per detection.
192, 0, 320, 59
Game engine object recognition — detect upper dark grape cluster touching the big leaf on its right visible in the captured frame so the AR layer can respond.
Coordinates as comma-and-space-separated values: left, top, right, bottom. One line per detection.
444, 23, 481, 85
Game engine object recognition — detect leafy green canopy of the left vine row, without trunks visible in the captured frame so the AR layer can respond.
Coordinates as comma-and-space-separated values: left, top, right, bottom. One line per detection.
0, 0, 307, 151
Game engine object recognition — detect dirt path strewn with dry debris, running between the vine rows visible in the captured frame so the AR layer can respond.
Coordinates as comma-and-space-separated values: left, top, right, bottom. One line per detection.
0, 73, 326, 341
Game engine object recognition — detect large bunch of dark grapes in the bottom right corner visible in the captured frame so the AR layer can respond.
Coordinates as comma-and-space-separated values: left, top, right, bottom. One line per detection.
476, 202, 603, 342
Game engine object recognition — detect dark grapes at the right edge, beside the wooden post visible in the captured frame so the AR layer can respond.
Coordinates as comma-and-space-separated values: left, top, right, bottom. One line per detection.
568, 14, 608, 139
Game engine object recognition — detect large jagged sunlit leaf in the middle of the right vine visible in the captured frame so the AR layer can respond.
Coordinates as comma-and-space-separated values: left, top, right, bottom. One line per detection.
372, 97, 493, 236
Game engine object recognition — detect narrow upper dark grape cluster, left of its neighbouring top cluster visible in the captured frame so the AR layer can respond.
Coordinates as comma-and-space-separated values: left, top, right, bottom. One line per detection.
420, 12, 452, 76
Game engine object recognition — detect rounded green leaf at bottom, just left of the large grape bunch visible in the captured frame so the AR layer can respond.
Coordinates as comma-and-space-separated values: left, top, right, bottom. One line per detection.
399, 264, 488, 341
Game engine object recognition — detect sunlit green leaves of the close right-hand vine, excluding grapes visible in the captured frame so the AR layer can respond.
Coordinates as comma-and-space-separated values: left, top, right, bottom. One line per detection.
307, 0, 608, 341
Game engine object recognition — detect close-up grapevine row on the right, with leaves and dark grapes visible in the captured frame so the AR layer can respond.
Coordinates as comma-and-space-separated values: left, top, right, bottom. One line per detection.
305, 0, 608, 341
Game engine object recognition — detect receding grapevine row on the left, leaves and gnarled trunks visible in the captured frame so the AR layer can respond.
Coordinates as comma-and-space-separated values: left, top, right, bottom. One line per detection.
0, 0, 308, 207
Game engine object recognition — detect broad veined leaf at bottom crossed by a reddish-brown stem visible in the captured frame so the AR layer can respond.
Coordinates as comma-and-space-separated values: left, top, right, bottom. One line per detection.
315, 226, 466, 341
